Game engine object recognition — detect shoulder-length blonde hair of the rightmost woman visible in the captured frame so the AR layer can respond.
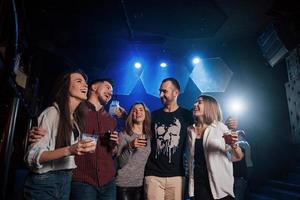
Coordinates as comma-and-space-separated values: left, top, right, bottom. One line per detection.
196, 95, 222, 125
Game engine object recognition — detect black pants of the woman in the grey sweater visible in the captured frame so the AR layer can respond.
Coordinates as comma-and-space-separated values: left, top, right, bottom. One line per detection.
117, 186, 144, 200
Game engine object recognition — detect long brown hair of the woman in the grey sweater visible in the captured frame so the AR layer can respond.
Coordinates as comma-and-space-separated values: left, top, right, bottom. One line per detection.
125, 102, 152, 138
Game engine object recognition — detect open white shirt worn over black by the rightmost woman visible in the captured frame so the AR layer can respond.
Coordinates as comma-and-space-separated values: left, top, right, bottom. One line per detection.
188, 122, 234, 199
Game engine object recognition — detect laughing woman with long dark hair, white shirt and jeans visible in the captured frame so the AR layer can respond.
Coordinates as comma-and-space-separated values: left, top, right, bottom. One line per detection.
24, 71, 96, 200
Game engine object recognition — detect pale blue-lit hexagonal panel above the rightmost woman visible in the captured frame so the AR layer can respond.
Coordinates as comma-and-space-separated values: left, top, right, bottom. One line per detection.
190, 57, 233, 92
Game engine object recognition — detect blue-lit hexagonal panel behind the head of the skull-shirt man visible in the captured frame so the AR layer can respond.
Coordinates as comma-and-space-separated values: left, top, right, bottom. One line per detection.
140, 62, 189, 97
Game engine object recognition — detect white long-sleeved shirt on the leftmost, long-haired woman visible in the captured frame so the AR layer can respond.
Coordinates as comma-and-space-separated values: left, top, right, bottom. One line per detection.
24, 104, 76, 174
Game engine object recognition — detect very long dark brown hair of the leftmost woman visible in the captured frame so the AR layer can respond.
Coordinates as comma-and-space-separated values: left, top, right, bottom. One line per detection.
54, 70, 87, 149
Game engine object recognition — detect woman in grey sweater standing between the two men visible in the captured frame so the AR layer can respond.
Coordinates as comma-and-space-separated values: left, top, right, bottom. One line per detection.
116, 102, 151, 200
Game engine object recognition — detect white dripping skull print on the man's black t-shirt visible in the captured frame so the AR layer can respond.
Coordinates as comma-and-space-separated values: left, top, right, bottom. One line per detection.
154, 118, 181, 163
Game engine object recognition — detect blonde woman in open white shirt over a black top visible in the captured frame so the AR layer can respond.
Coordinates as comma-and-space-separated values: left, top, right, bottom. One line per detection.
188, 95, 243, 200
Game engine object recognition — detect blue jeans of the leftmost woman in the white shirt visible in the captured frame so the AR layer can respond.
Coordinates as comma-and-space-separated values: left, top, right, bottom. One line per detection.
24, 170, 72, 200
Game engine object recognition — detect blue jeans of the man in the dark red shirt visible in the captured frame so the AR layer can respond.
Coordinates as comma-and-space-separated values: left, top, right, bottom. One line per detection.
71, 180, 116, 200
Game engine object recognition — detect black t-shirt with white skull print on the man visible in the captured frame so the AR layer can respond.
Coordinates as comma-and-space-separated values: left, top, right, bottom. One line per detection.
145, 107, 193, 177
